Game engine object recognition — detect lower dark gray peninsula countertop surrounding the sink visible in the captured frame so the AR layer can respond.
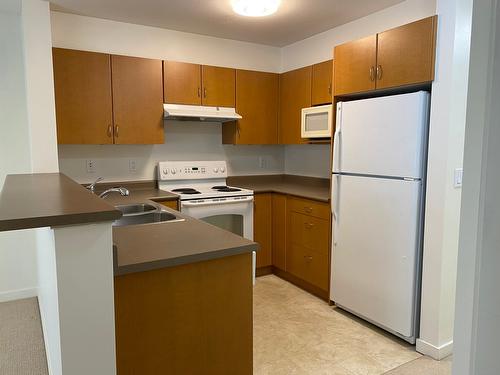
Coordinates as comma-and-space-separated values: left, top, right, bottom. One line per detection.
110, 190, 258, 276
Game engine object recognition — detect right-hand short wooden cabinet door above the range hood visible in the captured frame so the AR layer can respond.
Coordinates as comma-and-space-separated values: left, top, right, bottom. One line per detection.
201, 65, 236, 107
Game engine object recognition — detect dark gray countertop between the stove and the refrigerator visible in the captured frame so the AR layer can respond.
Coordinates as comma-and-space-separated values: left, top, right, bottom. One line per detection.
227, 174, 330, 202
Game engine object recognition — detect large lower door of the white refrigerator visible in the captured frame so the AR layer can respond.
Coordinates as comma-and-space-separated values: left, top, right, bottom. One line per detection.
330, 174, 422, 341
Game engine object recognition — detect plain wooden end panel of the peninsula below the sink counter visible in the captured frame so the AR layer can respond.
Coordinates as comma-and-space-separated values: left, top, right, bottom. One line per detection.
114, 254, 253, 375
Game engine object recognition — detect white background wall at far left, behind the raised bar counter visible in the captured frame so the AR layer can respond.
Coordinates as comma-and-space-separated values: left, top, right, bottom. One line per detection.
0, 1, 37, 301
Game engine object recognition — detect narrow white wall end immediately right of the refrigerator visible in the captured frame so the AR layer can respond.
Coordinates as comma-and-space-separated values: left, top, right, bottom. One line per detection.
417, 0, 471, 358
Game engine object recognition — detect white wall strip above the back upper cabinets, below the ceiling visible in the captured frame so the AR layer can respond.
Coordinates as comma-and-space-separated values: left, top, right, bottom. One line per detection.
51, 12, 280, 72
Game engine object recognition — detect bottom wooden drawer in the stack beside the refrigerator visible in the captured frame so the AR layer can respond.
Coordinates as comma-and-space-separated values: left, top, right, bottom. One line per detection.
286, 244, 329, 290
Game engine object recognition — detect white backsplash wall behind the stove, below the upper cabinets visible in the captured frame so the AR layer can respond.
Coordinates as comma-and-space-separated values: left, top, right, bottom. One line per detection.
59, 121, 284, 183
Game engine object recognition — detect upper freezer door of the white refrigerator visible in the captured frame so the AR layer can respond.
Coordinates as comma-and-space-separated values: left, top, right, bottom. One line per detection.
333, 91, 429, 178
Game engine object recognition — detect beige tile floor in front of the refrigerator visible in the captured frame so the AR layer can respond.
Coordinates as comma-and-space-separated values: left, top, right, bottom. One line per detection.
254, 275, 451, 375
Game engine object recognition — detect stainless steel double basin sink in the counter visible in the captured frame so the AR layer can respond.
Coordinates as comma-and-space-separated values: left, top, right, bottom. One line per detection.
113, 203, 184, 227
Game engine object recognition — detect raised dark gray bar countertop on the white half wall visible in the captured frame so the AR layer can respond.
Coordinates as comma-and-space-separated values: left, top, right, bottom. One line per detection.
0, 173, 121, 231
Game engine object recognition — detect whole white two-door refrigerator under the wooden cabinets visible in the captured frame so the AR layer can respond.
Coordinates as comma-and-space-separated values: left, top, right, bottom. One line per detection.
330, 91, 429, 343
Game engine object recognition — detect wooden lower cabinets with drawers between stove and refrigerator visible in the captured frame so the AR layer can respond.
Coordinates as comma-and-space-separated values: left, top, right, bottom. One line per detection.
254, 193, 331, 298
